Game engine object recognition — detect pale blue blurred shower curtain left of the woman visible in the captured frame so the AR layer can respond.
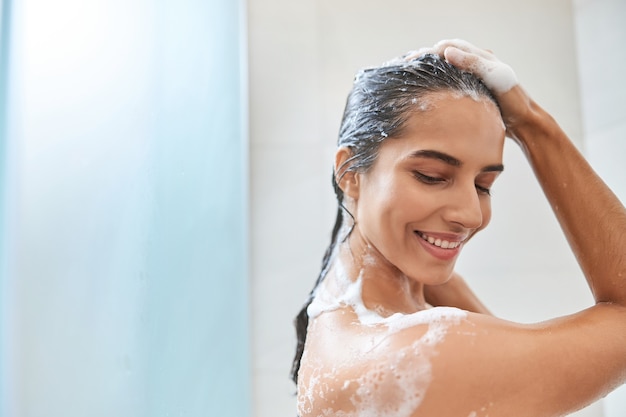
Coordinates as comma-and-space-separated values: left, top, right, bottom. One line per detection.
0, 0, 250, 417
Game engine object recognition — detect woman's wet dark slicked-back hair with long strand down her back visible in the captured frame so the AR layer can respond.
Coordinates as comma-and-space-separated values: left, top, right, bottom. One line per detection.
291, 54, 497, 384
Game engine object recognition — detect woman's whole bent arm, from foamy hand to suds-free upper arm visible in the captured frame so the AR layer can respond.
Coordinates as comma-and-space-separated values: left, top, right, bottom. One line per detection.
412, 41, 626, 416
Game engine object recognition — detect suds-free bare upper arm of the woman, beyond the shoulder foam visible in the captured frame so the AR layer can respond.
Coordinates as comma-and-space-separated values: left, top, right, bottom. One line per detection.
416, 305, 626, 417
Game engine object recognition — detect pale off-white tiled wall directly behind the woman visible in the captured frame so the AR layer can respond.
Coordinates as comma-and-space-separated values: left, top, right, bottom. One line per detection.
248, 0, 602, 417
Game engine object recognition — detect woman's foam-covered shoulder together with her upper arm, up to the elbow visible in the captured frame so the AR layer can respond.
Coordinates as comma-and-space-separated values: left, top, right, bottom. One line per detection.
298, 305, 626, 417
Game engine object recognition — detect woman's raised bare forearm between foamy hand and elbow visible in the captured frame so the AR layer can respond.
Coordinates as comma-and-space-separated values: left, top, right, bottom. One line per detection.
507, 92, 626, 305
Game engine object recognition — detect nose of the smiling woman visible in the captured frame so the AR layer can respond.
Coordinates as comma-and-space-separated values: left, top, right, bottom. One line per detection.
444, 182, 486, 229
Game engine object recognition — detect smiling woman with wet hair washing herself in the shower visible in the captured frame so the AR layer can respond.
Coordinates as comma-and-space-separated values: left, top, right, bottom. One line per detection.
292, 41, 626, 417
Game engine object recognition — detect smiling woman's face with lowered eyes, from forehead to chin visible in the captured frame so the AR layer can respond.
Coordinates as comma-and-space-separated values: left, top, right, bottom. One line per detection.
353, 93, 505, 284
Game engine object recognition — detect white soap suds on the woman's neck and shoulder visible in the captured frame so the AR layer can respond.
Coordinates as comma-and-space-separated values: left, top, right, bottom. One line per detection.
298, 260, 467, 417
